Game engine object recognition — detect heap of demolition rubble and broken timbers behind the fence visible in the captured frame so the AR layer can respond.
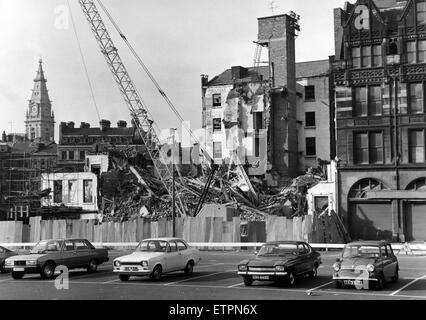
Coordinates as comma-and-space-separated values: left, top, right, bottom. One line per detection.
101, 152, 324, 222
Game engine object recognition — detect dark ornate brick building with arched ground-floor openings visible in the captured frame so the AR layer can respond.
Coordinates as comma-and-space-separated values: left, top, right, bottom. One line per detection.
333, 0, 426, 241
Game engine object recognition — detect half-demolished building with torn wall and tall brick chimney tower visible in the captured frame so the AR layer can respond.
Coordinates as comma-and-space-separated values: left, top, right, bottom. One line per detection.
202, 15, 331, 181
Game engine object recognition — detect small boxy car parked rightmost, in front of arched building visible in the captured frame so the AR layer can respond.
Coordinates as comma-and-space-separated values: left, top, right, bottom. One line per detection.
333, 241, 399, 290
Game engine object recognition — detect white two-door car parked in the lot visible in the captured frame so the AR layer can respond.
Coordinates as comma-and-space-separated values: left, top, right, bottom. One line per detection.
114, 238, 201, 281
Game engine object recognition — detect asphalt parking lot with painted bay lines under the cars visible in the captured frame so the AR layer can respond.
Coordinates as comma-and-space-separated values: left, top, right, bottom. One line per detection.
0, 252, 426, 300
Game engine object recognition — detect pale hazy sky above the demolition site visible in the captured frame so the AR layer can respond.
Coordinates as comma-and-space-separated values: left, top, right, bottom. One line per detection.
0, 0, 345, 140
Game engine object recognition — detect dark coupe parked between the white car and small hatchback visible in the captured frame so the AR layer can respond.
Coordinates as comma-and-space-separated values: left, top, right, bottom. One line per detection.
238, 241, 321, 287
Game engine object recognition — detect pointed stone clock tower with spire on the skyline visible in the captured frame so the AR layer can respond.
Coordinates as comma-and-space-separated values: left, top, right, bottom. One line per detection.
25, 59, 55, 142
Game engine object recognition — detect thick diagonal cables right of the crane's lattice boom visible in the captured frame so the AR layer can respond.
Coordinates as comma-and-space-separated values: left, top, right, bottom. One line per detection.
97, 0, 208, 160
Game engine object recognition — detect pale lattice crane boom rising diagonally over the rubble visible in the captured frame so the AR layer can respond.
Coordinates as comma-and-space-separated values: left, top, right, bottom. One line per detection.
79, 0, 187, 214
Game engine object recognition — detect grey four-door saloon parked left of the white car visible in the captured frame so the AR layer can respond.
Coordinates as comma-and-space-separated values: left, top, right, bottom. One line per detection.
5, 239, 108, 279
